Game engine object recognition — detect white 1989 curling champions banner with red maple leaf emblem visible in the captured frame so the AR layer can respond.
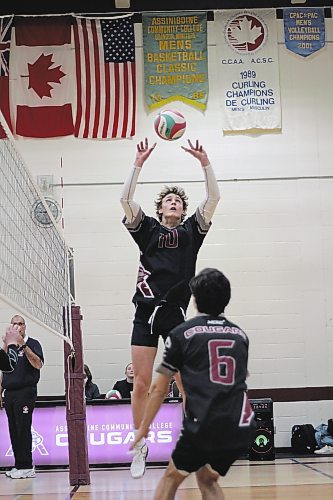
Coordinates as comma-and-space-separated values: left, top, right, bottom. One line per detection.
215, 9, 281, 133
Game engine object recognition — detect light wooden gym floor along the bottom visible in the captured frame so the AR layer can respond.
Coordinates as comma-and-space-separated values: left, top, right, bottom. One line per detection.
0, 455, 333, 500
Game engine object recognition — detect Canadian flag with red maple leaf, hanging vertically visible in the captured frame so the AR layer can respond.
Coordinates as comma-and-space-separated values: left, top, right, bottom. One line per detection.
9, 16, 76, 138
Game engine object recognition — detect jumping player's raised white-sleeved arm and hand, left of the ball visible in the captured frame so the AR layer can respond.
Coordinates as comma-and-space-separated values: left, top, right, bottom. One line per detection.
120, 138, 156, 223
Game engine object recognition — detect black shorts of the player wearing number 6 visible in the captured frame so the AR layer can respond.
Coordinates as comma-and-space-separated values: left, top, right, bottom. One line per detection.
171, 430, 244, 476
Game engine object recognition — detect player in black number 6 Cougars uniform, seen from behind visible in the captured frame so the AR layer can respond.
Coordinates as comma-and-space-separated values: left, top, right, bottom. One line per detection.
132, 268, 255, 500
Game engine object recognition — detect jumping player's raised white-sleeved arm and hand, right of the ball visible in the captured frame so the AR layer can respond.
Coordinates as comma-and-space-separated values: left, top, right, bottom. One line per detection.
182, 139, 220, 224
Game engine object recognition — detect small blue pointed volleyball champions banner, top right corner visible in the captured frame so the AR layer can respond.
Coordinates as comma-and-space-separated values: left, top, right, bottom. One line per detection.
283, 8, 325, 57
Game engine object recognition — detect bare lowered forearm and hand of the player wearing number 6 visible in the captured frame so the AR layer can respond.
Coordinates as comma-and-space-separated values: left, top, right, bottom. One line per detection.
130, 374, 171, 450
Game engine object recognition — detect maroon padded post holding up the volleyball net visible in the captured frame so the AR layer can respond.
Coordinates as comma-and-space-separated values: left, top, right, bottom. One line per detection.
64, 306, 90, 486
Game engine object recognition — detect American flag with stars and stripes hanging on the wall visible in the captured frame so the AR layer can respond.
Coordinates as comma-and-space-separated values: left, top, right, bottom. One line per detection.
74, 16, 136, 139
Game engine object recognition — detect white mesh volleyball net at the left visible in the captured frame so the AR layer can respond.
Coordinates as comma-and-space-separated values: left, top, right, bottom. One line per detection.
0, 112, 74, 353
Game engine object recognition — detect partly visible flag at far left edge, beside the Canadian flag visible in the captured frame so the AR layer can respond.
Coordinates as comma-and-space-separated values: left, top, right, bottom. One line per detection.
0, 16, 13, 139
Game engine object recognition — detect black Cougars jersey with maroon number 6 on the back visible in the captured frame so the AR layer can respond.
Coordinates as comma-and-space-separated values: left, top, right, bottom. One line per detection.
157, 315, 254, 449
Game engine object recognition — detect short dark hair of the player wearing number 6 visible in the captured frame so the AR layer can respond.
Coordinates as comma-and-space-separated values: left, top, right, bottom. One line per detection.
190, 267, 231, 316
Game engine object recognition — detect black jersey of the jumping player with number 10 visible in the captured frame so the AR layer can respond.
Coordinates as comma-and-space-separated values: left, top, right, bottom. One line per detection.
123, 209, 211, 310
